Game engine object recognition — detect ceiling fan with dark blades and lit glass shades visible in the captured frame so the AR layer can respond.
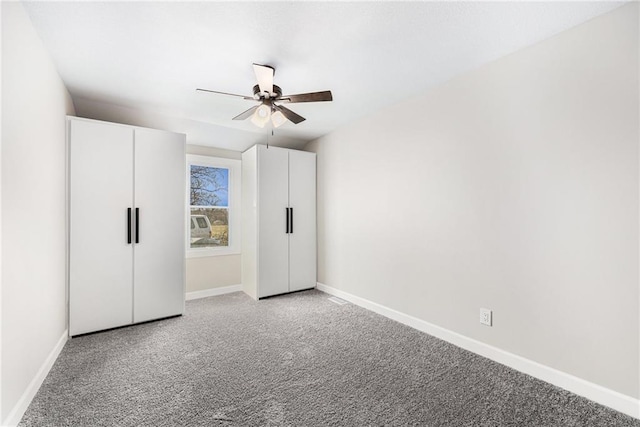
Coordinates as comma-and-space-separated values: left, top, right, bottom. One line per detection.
196, 64, 333, 128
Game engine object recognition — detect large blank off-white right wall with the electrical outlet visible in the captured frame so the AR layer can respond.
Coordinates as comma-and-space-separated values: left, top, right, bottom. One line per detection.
307, 3, 640, 398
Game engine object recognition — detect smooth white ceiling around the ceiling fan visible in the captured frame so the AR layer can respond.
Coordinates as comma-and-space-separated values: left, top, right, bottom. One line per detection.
25, 1, 622, 151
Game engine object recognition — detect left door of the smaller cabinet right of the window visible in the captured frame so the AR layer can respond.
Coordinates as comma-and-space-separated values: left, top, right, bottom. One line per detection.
258, 145, 289, 298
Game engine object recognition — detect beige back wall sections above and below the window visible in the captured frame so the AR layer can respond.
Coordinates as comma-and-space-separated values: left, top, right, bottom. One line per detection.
187, 144, 242, 292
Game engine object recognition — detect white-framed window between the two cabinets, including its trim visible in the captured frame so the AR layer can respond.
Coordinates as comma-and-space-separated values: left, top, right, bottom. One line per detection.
187, 155, 240, 257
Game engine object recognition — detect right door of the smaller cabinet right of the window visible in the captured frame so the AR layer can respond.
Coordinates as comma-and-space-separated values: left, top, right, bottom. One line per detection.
289, 150, 316, 291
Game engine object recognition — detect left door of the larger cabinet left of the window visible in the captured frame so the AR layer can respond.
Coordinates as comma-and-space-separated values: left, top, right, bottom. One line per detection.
69, 120, 133, 335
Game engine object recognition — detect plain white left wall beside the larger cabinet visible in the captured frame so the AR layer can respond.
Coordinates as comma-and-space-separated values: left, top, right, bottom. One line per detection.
0, 2, 74, 422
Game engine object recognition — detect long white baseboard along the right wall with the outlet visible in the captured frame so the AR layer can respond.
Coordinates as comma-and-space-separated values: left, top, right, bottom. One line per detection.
317, 282, 640, 419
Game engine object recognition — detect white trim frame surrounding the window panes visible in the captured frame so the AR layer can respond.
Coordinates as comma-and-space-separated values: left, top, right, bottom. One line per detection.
185, 154, 242, 258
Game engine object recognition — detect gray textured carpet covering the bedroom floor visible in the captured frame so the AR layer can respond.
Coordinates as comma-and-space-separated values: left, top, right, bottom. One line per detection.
20, 290, 640, 427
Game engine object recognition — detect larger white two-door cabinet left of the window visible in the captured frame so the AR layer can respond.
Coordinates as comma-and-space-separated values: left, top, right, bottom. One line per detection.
68, 117, 185, 335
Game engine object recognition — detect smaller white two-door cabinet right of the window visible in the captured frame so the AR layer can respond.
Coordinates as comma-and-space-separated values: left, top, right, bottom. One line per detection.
242, 145, 316, 298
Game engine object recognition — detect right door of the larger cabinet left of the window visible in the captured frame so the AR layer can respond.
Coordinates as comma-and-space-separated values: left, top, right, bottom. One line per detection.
133, 129, 186, 323
